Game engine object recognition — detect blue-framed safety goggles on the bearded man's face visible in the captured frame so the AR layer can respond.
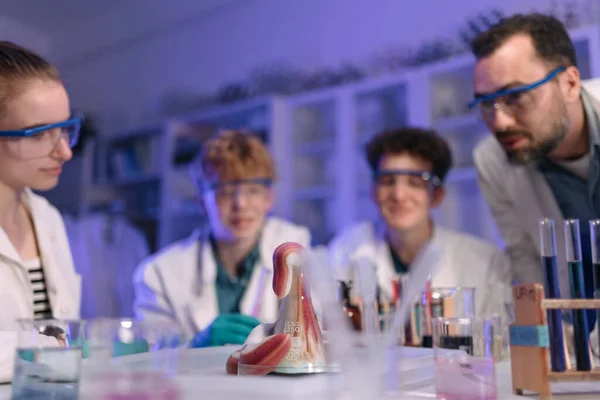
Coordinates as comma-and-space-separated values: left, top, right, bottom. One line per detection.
468, 67, 567, 120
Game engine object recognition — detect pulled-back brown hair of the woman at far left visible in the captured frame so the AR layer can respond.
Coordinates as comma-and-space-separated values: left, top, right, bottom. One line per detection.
0, 41, 61, 112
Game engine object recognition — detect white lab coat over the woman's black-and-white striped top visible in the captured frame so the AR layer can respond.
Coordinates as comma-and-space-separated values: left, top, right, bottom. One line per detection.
0, 189, 81, 383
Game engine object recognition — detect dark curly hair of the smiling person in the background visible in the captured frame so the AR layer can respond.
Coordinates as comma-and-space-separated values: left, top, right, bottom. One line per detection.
365, 127, 452, 182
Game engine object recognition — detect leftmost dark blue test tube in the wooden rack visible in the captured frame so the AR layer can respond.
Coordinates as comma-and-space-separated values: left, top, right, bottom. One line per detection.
538, 218, 566, 372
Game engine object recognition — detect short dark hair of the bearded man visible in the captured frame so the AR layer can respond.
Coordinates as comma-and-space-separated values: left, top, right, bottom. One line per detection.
471, 13, 577, 67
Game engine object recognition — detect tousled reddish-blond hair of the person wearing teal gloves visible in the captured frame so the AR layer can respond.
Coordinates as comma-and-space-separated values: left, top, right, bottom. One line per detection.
191, 130, 275, 186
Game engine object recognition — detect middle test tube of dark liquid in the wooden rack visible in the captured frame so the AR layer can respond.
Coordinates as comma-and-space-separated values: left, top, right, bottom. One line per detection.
565, 219, 592, 371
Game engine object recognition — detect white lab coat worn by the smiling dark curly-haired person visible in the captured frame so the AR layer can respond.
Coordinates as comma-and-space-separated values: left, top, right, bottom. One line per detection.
330, 222, 512, 321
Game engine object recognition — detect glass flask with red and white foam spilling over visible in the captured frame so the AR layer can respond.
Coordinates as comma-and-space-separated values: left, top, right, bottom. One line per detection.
227, 242, 326, 375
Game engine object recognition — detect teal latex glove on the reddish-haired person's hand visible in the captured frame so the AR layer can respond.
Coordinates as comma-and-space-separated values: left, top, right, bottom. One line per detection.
190, 314, 260, 347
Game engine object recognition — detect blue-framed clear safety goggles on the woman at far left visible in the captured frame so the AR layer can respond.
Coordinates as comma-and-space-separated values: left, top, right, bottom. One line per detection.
0, 117, 83, 159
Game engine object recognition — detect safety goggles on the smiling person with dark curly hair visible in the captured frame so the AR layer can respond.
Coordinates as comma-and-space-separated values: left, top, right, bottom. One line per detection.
373, 169, 442, 191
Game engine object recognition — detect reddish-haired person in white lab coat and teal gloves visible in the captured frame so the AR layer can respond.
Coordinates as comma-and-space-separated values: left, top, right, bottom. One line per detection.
134, 131, 310, 347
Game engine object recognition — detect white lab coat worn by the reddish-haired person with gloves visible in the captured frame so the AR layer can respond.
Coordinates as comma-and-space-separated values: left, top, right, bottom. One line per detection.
134, 218, 310, 337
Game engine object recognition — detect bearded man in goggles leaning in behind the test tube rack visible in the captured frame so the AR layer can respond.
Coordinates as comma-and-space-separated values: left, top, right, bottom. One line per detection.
471, 14, 600, 328
